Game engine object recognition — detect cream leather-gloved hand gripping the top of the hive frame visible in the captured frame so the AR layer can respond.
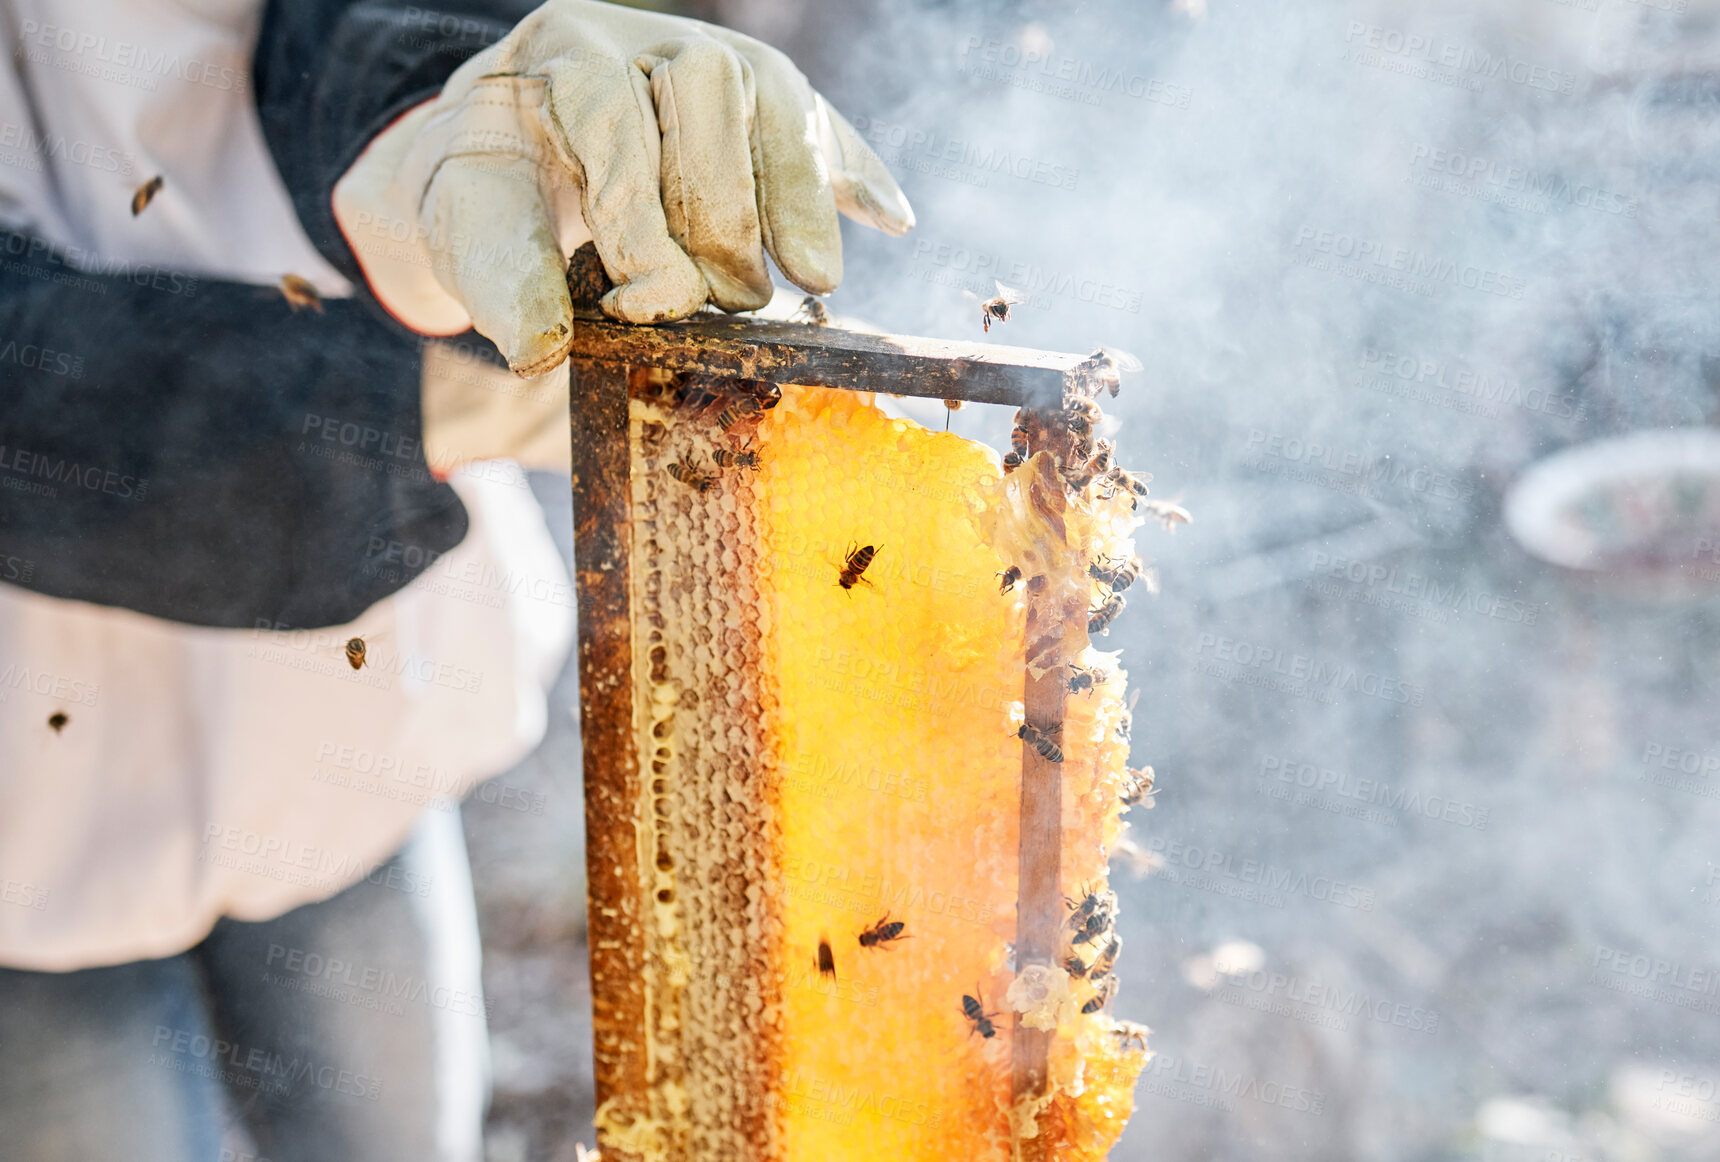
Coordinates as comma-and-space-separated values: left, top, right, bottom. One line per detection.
334, 0, 913, 375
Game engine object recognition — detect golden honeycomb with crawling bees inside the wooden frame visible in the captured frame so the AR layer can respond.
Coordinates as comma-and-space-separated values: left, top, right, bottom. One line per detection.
599, 375, 1147, 1162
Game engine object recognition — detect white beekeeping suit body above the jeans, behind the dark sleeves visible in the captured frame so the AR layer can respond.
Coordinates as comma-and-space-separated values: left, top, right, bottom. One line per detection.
0, 0, 573, 971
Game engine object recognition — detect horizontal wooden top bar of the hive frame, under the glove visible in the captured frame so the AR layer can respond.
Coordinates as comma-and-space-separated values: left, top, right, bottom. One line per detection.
568, 313, 1085, 407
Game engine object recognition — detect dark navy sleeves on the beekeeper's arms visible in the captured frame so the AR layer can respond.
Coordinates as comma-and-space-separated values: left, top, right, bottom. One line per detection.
0, 0, 533, 627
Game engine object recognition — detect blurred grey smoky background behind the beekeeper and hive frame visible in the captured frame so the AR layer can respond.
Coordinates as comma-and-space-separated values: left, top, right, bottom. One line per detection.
464, 0, 1720, 1162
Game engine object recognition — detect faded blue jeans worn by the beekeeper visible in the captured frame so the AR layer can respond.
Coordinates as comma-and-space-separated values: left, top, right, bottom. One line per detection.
0, 810, 488, 1162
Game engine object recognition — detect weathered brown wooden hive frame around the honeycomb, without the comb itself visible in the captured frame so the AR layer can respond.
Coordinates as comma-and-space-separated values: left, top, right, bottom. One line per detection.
569, 315, 1084, 1159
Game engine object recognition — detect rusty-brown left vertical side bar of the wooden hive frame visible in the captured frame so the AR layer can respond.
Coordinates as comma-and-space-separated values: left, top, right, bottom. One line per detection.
569, 361, 650, 1162
